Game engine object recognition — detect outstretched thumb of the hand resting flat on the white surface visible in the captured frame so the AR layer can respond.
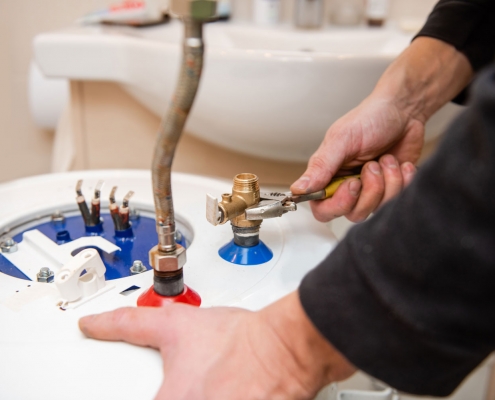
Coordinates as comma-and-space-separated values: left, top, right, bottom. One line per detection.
79, 307, 167, 349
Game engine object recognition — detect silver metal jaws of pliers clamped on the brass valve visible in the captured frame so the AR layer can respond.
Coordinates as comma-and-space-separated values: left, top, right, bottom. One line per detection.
246, 192, 297, 221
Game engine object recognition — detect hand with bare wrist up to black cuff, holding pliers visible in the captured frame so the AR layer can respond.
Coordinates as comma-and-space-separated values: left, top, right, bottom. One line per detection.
291, 37, 473, 225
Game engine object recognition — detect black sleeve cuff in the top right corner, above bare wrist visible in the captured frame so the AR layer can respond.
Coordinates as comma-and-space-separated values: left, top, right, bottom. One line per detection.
415, 0, 495, 104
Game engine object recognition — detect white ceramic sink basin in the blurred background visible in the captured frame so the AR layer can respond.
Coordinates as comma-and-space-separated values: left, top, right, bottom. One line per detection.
34, 21, 462, 161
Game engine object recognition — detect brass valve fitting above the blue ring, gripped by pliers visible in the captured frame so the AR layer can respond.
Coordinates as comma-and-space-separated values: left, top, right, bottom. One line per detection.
218, 173, 261, 228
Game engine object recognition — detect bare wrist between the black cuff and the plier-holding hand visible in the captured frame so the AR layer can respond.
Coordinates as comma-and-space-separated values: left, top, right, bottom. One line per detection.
371, 37, 473, 123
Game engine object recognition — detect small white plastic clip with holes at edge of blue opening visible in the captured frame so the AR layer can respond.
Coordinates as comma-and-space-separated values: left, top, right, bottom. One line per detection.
55, 249, 113, 308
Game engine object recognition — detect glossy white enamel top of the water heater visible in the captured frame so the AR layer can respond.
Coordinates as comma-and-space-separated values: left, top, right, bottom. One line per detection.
0, 170, 336, 400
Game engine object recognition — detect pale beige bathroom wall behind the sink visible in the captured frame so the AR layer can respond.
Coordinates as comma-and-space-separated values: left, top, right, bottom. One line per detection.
0, 0, 435, 182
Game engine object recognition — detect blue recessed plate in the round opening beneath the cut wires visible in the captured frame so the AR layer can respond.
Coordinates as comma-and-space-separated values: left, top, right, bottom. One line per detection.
0, 214, 187, 280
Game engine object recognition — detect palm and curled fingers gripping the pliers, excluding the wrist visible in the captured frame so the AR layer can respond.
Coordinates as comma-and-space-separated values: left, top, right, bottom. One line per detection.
291, 95, 424, 222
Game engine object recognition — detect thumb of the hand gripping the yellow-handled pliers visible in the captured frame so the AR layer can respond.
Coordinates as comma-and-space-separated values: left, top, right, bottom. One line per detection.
290, 142, 344, 194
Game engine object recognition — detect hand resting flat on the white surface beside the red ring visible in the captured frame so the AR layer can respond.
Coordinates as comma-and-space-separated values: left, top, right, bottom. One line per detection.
79, 293, 355, 400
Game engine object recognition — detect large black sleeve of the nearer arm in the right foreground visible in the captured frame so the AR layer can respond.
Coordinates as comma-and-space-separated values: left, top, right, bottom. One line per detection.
299, 67, 495, 396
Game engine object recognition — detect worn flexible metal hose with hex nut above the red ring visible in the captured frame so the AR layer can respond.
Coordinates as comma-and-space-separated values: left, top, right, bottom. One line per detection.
143, 0, 216, 303
